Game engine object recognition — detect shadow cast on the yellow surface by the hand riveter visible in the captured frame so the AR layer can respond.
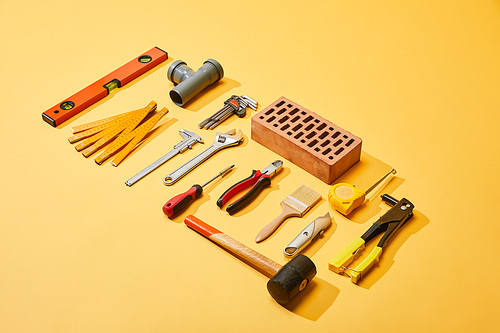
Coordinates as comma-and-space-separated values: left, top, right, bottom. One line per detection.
356, 210, 430, 289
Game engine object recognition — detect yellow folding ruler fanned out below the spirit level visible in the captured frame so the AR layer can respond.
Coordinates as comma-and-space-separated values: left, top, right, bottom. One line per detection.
68, 101, 168, 166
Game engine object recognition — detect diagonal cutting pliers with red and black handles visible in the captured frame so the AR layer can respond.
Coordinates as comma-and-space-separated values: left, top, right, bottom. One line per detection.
217, 160, 283, 215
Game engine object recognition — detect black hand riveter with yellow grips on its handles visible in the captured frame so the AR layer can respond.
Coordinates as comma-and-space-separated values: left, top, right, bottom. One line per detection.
328, 194, 414, 283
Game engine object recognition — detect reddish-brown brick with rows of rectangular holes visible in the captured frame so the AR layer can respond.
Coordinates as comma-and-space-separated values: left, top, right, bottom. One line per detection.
252, 97, 362, 184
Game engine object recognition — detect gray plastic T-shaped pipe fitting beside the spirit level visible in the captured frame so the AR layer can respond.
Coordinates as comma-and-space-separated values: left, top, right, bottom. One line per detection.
167, 59, 224, 106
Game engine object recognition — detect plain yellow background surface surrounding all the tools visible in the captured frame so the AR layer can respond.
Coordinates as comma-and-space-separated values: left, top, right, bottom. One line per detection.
0, 0, 500, 332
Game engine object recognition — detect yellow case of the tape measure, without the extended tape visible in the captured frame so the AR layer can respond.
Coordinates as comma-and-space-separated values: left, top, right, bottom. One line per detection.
328, 183, 366, 215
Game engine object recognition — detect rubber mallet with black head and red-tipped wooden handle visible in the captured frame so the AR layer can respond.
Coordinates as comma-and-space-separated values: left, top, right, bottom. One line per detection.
184, 215, 316, 304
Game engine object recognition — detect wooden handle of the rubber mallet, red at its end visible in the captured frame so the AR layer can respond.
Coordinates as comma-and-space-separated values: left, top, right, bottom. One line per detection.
184, 215, 282, 278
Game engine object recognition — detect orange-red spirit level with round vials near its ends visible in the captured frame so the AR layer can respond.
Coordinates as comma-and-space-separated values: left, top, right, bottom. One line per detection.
42, 47, 168, 127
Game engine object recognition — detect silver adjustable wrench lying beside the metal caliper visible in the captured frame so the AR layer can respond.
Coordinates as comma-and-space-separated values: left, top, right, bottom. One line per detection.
163, 129, 243, 185
